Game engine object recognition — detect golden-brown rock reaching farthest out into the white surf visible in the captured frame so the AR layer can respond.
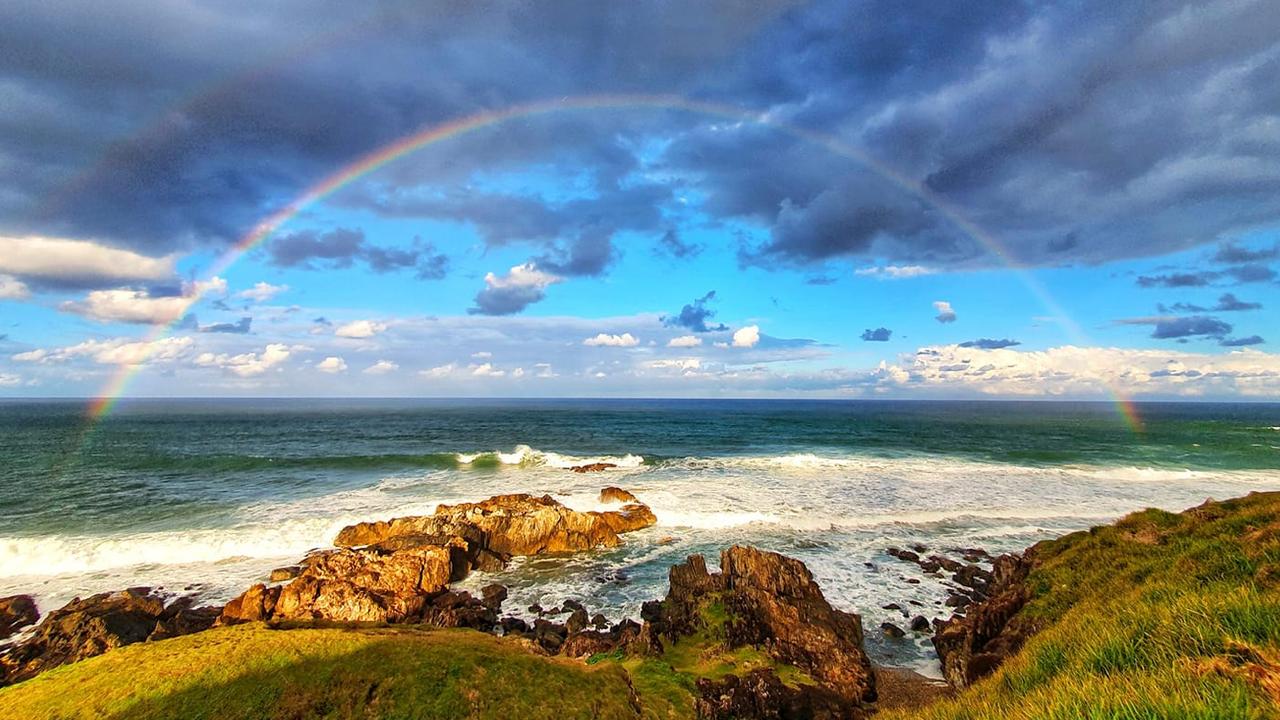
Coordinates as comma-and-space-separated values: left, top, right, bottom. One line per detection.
334, 495, 657, 557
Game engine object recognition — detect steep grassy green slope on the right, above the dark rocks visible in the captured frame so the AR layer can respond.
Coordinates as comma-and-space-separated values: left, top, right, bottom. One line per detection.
884, 493, 1280, 720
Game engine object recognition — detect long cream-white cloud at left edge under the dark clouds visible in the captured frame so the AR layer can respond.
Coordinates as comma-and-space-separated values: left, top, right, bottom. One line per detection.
0, 236, 177, 283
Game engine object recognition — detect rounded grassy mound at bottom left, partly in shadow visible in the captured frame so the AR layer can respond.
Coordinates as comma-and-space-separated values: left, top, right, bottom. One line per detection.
0, 624, 637, 720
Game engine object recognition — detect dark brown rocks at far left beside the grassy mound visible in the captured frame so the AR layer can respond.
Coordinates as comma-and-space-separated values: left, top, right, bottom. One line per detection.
0, 588, 218, 684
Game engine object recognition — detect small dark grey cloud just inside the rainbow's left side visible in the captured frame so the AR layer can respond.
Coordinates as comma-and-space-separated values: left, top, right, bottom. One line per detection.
265, 228, 448, 279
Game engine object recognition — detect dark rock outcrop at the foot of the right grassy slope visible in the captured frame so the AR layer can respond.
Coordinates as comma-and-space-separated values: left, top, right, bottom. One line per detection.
933, 552, 1038, 688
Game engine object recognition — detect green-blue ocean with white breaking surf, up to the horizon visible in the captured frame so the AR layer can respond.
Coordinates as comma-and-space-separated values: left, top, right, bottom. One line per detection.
0, 400, 1280, 674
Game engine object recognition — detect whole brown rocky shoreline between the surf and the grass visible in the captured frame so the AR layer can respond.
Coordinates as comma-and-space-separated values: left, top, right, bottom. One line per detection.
0, 484, 1049, 719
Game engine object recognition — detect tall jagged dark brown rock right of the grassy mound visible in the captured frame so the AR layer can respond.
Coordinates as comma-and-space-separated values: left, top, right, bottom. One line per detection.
637, 546, 876, 706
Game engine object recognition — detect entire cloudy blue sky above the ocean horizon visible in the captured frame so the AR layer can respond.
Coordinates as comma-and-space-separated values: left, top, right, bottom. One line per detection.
0, 0, 1280, 400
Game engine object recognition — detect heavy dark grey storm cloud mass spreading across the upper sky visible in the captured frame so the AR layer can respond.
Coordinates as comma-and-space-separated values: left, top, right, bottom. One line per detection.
0, 0, 1280, 272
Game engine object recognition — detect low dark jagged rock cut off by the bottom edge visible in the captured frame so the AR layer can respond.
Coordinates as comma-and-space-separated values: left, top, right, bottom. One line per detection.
695, 669, 868, 720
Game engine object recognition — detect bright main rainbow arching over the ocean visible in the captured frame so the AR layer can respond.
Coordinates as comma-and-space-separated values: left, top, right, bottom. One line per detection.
80, 94, 1143, 433
